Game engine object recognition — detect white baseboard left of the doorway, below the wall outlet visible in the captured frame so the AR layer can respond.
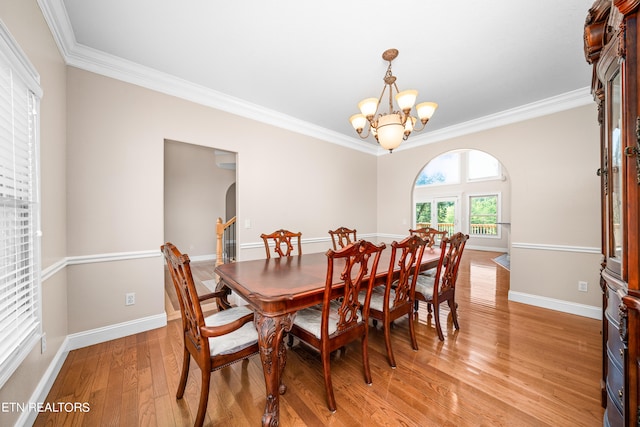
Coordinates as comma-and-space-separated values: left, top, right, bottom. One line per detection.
67, 312, 167, 351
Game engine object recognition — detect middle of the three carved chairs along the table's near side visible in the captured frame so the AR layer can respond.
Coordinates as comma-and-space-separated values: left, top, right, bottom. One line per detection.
359, 234, 427, 368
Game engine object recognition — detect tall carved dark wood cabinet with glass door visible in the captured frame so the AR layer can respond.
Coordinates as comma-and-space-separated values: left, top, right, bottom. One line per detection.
584, 0, 640, 426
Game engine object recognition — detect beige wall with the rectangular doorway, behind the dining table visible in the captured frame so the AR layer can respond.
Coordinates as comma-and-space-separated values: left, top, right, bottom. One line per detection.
67, 68, 376, 332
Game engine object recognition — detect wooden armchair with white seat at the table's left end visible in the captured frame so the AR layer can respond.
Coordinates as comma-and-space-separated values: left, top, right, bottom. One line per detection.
161, 242, 259, 427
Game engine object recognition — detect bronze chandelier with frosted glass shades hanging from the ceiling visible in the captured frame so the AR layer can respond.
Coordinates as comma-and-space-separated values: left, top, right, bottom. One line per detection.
349, 49, 438, 153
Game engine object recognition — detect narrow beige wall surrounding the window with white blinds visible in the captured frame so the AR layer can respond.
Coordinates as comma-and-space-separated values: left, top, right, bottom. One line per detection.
0, 0, 69, 426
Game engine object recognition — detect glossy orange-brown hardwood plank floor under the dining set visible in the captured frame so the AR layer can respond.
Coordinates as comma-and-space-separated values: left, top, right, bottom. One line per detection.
34, 250, 603, 427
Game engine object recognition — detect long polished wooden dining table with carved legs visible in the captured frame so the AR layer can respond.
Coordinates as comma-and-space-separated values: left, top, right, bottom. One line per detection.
215, 247, 440, 426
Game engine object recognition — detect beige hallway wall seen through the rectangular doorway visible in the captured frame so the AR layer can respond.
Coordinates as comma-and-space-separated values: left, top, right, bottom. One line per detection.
163, 141, 236, 261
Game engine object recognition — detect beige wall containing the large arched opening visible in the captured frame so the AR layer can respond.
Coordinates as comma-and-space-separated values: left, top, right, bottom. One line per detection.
378, 105, 601, 307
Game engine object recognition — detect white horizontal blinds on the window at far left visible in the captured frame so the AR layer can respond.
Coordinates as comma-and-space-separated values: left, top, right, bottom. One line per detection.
0, 21, 41, 387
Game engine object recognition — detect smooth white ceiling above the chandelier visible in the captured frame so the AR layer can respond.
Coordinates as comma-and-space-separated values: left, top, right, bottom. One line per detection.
39, 0, 593, 154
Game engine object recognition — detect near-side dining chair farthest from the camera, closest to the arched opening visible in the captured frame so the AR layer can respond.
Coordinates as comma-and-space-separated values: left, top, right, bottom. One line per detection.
415, 232, 469, 341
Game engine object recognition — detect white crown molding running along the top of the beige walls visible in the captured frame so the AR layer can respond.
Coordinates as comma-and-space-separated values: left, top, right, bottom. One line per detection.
37, 0, 593, 156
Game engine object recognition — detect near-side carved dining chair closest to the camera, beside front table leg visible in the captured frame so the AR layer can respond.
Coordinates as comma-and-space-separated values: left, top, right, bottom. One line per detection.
289, 240, 385, 412
